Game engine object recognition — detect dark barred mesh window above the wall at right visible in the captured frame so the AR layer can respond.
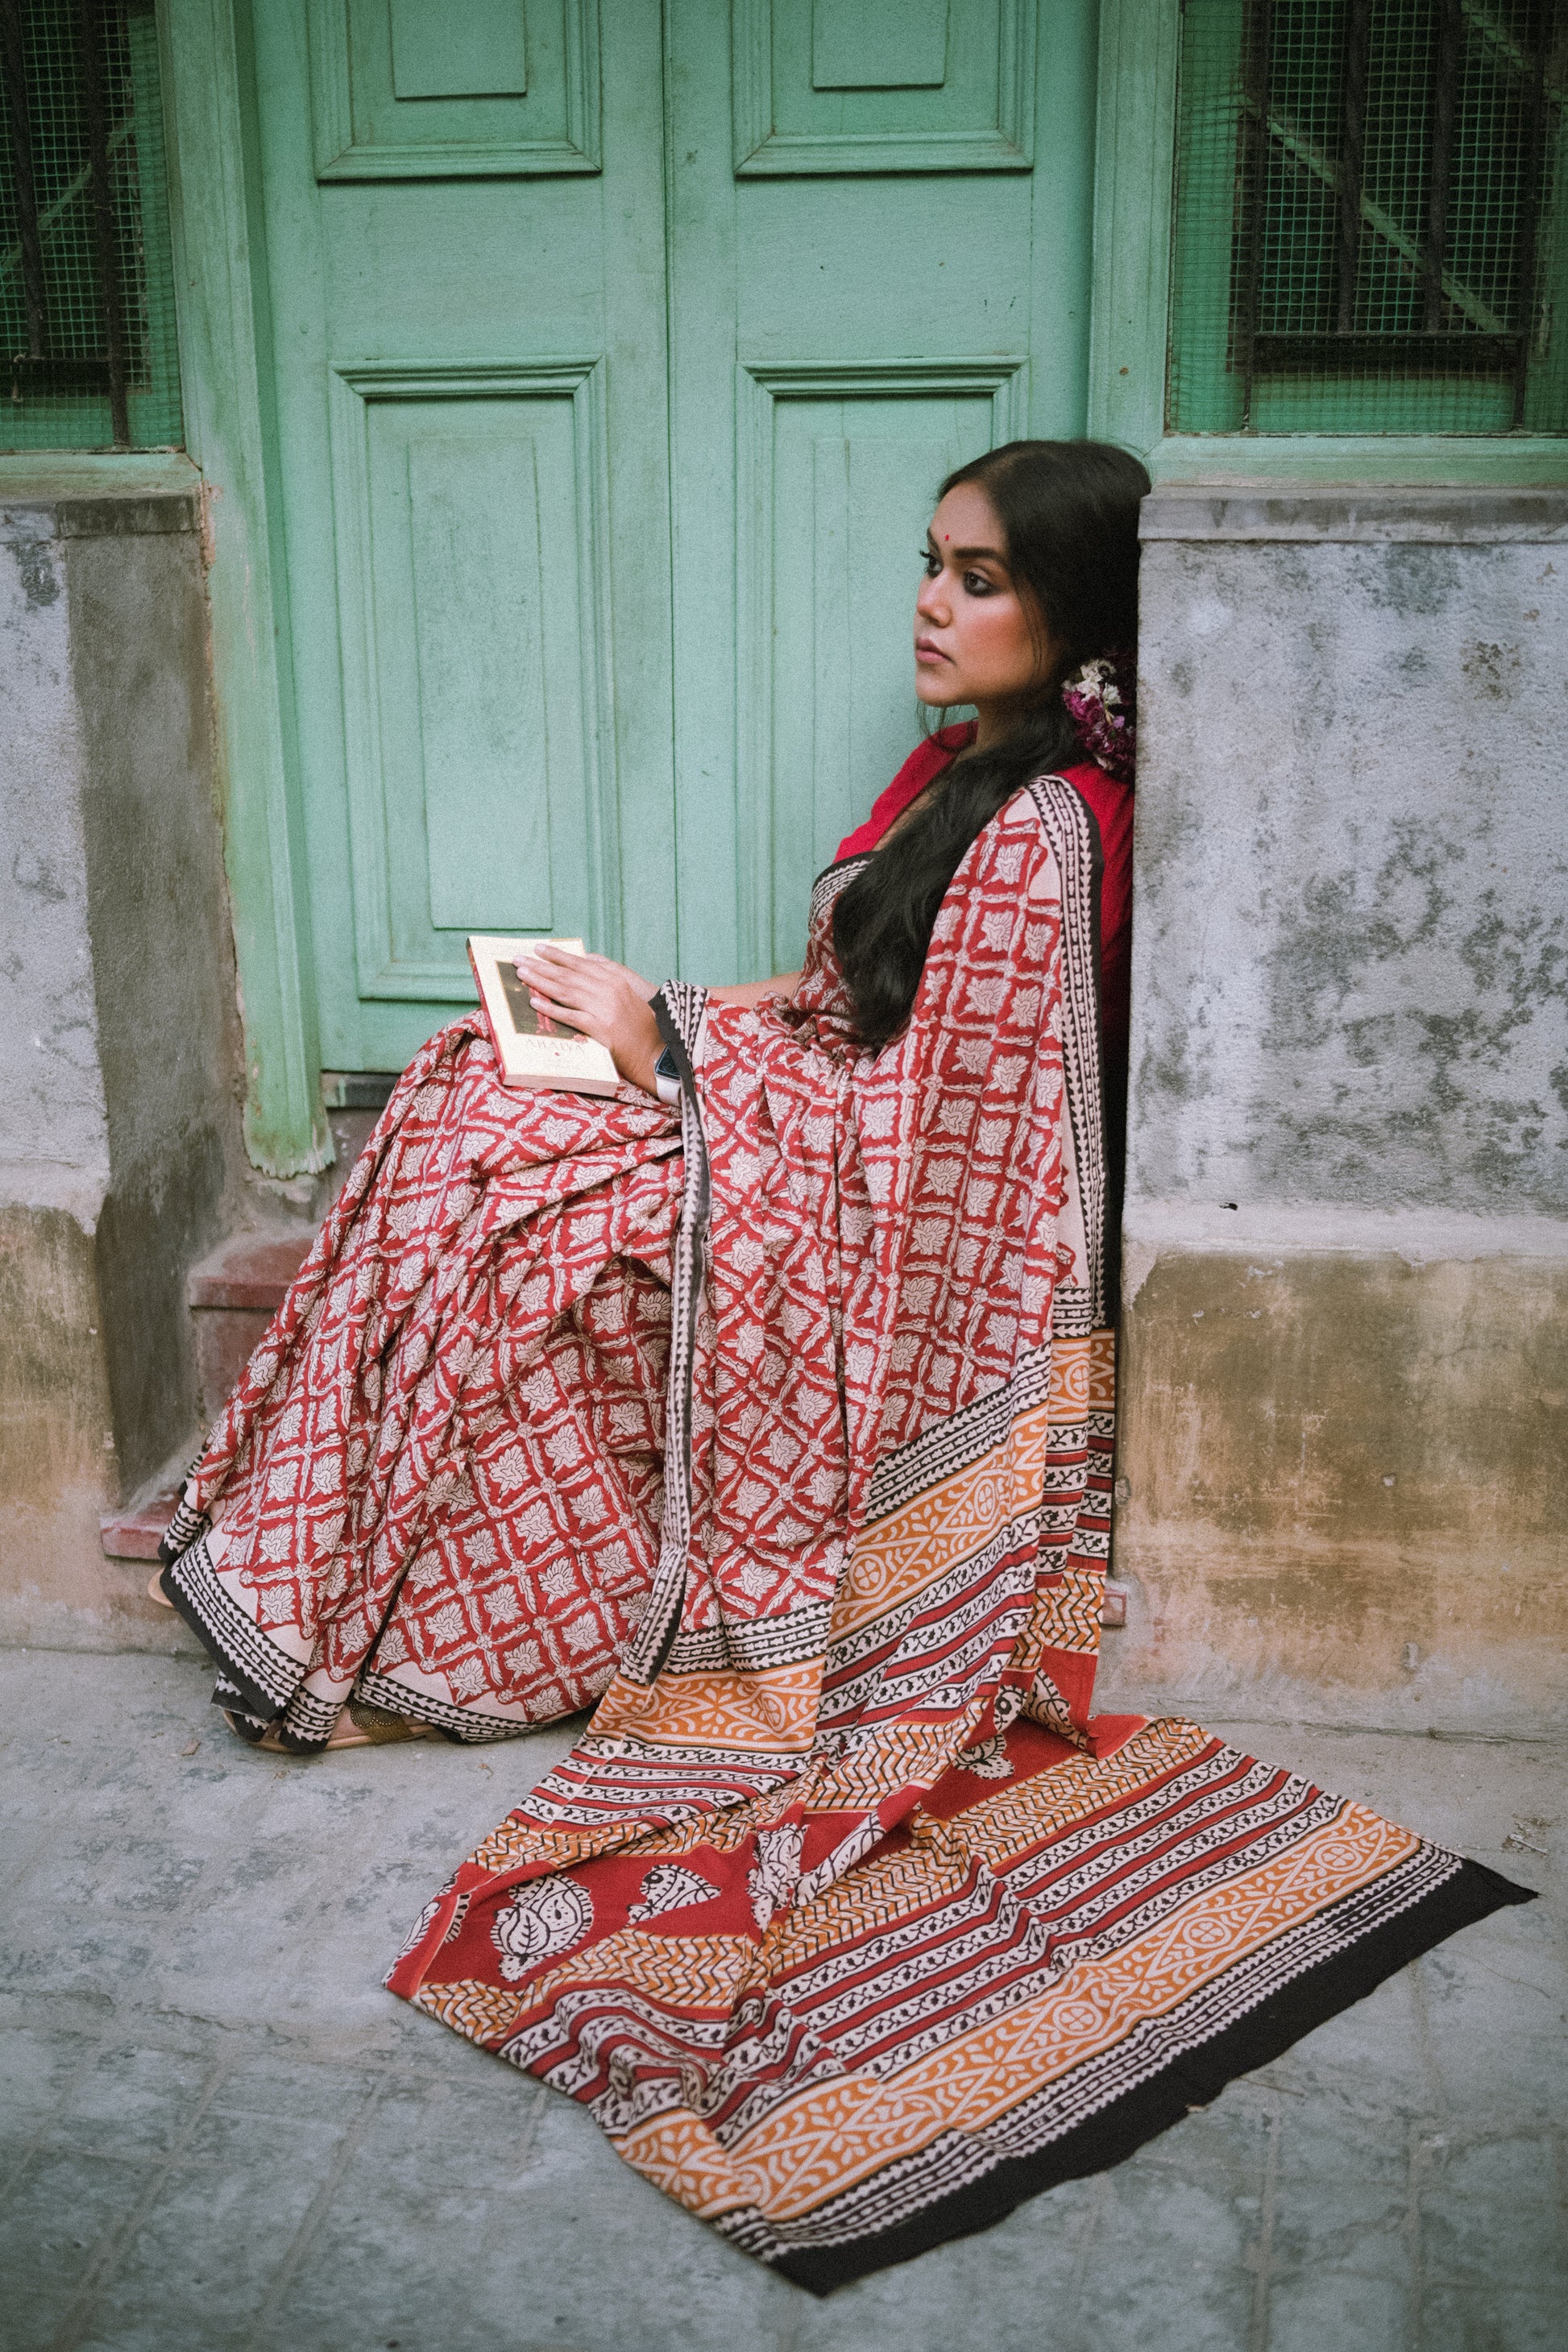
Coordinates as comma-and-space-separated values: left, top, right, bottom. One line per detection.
1166, 0, 1568, 433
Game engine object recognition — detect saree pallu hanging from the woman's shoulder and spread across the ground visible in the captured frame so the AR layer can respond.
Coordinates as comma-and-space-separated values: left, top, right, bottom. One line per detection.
388, 778, 1525, 2293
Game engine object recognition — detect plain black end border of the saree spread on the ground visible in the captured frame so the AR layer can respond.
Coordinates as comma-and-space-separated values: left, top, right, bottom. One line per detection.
770, 1860, 1535, 2296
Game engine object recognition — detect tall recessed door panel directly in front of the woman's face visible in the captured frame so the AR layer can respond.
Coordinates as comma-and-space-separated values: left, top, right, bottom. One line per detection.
738, 363, 1020, 972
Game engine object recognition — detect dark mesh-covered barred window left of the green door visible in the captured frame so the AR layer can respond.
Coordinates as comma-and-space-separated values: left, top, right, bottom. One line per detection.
0, 0, 181, 450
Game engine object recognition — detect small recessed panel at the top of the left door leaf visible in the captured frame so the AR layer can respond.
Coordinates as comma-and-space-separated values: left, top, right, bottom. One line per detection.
308, 0, 599, 181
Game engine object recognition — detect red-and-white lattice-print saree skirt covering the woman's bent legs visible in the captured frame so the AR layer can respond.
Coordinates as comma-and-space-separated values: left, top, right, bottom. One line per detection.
164, 1014, 682, 1750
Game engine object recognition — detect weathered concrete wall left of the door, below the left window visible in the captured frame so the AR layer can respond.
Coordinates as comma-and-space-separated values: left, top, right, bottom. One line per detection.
0, 461, 243, 1641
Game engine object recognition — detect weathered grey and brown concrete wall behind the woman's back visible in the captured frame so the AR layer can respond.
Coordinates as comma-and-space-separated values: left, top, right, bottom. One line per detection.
1112, 489, 1568, 1728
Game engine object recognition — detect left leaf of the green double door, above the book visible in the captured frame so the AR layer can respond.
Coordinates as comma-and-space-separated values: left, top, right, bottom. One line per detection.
251, 0, 674, 1070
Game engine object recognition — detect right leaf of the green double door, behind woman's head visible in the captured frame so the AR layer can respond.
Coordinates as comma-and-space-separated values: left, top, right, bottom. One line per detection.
666, 0, 1097, 981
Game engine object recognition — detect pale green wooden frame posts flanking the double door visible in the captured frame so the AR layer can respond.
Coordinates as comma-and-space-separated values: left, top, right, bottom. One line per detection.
157, 0, 1180, 1178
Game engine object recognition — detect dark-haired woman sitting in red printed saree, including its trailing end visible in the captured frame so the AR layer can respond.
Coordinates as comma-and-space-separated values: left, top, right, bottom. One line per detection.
169, 442, 1524, 2291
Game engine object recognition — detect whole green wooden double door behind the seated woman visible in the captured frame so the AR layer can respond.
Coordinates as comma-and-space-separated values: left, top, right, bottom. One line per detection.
254, 0, 1093, 1070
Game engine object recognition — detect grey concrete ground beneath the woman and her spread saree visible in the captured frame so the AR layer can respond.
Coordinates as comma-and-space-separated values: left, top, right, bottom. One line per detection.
0, 1651, 1568, 2352
